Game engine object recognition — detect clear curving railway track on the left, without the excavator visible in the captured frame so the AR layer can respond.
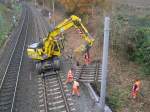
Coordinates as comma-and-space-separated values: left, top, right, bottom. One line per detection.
0, 8, 29, 112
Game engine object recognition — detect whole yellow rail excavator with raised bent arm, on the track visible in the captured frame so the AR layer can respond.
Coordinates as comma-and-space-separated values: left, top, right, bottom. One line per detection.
27, 15, 94, 73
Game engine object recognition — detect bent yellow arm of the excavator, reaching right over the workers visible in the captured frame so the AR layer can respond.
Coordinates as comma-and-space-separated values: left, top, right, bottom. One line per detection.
43, 15, 94, 57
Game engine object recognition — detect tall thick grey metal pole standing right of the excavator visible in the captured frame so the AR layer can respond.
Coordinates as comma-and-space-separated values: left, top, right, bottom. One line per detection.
100, 17, 110, 112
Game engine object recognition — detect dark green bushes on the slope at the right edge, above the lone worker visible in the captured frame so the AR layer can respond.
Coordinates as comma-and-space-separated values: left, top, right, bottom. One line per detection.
127, 15, 150, 75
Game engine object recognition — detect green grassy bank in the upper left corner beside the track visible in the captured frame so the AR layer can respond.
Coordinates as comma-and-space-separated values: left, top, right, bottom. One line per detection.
0, 4, 21, 47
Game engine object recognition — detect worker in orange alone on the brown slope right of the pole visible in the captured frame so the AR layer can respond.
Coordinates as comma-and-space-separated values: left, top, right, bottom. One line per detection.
132, 80, 141, 99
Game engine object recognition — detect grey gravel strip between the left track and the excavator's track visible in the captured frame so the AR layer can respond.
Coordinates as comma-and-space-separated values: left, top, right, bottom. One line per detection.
14, 3, 39, 112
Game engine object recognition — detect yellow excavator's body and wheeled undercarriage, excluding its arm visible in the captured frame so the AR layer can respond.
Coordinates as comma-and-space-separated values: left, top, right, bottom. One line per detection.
27, 40, 61, 73
